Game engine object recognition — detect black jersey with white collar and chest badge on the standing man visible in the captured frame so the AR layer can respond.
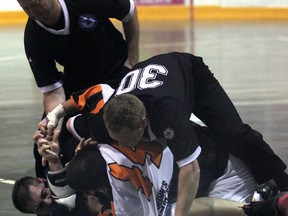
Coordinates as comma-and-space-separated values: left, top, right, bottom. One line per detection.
24, 0, 135, 95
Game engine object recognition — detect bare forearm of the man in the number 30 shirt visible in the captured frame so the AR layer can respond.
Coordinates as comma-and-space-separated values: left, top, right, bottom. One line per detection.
175, 160, 200, 216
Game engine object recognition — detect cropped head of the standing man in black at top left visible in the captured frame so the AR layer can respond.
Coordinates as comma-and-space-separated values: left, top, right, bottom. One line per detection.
17, 0, 61, 24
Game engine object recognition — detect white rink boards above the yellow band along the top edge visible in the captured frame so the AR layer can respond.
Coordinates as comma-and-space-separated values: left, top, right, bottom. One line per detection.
0, 0, 288, 11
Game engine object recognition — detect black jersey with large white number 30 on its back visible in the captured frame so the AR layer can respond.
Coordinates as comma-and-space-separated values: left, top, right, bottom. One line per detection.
116, 52, 213, 164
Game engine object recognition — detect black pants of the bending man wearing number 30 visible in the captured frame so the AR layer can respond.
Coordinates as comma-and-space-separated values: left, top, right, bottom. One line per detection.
190, 57, 286, 184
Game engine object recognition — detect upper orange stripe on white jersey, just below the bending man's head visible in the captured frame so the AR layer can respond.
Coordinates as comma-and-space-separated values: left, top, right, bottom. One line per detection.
112, 140, 163, 168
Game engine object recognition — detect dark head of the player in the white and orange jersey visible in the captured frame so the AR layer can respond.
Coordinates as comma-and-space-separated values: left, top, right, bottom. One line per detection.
66, 150, 109, 192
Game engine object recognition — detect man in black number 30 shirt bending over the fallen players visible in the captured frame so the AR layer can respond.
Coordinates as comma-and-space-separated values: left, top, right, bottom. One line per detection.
37, 52, 288, 215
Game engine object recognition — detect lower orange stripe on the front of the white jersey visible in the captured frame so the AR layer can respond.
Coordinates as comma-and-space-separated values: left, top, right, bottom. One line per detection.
109, 163, 153, 200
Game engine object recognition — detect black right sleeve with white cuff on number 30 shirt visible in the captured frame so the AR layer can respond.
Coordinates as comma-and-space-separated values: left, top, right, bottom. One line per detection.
148, 98, 201, 167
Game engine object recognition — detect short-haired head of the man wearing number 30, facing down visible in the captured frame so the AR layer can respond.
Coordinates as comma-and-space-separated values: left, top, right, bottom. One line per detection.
103, 94, 147, 147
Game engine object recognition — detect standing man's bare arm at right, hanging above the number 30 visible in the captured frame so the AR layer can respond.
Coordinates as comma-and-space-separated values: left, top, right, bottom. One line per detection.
122, 8, 139, 68
